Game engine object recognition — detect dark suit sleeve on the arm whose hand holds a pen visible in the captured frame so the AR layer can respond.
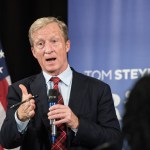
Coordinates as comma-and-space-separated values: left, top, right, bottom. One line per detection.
0, 86, 23, 148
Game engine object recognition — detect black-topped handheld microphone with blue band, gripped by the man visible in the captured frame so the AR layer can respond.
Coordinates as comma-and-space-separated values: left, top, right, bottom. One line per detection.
48, 89, 58, 144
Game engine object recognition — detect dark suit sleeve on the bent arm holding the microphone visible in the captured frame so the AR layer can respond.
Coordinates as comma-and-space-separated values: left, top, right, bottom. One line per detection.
71, 84, 121, 148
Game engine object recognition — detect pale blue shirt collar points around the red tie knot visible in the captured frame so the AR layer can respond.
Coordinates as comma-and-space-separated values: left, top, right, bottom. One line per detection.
43, 65, 72, 86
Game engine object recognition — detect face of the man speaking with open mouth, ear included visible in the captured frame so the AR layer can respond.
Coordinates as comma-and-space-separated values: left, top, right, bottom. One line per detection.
32, 23, 70, 75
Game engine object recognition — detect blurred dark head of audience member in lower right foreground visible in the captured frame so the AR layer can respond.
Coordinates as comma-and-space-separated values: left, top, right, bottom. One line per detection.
123, 75, 150, 150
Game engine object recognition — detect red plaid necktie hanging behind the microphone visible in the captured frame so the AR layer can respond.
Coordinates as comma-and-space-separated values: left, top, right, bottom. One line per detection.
50, 77, 67, 150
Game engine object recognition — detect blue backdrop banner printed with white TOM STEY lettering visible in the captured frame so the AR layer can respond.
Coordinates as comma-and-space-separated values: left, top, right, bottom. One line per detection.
68, 0, 150, 122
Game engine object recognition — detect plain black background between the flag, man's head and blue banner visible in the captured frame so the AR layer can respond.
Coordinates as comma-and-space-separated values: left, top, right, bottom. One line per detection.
0, 0, 67, 82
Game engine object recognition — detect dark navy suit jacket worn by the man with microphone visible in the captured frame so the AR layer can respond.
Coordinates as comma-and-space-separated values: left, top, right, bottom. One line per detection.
0, 70, 121, 150
